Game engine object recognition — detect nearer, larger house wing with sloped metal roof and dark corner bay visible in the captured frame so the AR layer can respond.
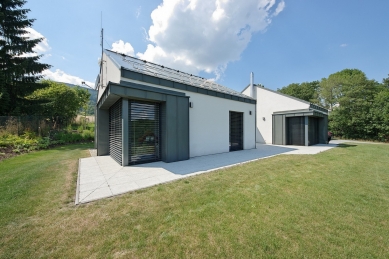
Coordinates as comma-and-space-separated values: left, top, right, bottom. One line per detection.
96, 50, 256, 166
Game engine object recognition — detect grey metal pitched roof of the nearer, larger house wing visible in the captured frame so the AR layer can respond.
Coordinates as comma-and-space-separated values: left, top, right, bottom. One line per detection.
104, 49, 255, 100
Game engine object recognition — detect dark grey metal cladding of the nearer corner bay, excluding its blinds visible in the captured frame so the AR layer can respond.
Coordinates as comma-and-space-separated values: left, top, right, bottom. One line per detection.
96, 82, 189, 166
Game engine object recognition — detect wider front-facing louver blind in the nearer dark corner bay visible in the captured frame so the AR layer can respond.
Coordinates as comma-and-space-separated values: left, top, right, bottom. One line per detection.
128, 101, 161, 165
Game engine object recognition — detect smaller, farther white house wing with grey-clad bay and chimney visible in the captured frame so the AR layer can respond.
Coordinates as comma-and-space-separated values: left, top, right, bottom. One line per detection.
242, 79, 328, 146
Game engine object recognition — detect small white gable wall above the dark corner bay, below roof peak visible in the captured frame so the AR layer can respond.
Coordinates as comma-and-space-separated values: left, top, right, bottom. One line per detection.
97, 53, 121, 100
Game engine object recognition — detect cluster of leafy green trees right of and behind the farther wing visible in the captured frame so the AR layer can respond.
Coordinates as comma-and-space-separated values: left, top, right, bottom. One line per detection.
278, 69, 389, 141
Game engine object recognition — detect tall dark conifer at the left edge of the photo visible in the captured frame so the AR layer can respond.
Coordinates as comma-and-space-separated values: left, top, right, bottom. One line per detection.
0, 0, 51, 115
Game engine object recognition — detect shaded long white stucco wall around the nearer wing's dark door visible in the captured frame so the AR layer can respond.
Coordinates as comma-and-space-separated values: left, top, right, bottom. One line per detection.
121, 78, 255, 157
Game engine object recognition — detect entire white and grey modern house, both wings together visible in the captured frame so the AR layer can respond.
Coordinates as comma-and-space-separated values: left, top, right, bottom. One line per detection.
95, 50, 328, 166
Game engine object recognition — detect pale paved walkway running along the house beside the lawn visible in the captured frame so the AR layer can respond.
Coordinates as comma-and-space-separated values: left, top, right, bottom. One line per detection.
75, 141, 344, 204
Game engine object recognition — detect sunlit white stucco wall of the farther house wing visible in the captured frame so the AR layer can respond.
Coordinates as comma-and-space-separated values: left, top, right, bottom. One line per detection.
256, 86, 309, 144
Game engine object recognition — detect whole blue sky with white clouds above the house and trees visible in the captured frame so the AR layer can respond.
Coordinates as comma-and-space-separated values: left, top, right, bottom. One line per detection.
25, 0, 389, 91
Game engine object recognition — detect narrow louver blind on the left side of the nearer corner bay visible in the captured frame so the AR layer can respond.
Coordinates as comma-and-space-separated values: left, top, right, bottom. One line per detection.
109, 99, 122, 165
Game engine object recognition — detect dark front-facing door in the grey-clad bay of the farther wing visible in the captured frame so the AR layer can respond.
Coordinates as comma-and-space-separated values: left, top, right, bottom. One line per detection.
287, 116, 305, 146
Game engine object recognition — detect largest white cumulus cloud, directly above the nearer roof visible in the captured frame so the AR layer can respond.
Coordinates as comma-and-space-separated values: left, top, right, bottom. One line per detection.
137, 0, 285, 79
